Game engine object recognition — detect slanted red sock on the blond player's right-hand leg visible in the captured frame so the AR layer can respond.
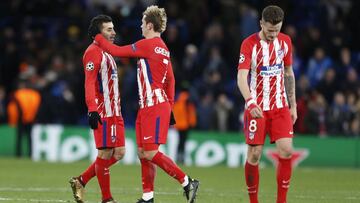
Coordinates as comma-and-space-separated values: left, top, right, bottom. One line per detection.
151, 152, 185, 184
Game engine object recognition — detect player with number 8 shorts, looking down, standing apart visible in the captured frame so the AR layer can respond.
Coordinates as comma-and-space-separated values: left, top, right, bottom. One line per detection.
237, 6, 297, 203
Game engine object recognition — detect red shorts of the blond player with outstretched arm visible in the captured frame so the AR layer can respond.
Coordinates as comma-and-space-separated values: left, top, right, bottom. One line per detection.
135, 102, 171, 147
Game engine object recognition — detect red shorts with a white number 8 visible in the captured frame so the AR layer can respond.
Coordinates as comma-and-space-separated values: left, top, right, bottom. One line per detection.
244, 107, 294, 145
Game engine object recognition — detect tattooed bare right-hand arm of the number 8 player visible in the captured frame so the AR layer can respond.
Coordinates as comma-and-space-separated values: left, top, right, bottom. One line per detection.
284, 66, 297, 123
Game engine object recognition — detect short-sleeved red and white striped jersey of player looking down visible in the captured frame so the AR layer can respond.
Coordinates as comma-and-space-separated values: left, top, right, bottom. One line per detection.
238, 33, 292, 111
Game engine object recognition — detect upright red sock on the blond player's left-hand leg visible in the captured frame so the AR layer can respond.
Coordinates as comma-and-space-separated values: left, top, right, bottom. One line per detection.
140, 159, 156, 193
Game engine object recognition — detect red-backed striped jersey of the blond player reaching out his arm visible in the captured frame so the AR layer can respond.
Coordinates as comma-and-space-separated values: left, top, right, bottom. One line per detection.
95, 35, 175, 108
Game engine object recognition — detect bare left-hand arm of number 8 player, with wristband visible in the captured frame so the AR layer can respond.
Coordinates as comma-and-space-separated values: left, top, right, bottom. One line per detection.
237, 69, 263, 118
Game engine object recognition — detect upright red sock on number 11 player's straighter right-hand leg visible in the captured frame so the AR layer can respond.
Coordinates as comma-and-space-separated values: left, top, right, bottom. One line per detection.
95, 157, 112, 200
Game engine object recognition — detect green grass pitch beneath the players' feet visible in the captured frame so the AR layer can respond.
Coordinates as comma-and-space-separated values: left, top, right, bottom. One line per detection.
0, 158, 360, 203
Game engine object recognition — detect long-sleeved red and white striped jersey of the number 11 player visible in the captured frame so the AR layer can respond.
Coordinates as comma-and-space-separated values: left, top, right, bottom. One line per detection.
83, 43, 121, 118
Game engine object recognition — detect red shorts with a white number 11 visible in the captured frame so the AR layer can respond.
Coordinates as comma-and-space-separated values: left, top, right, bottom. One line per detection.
94, 117, 125, 149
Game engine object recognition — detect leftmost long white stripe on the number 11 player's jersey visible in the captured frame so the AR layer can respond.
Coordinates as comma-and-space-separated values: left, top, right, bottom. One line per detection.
100, 54, 112, 117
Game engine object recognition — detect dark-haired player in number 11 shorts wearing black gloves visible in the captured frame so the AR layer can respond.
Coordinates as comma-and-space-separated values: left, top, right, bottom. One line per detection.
70, 15, 125, 203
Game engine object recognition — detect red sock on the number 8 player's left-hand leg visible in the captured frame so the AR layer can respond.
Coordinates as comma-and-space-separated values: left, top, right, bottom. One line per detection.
245, 162, 259, 203
